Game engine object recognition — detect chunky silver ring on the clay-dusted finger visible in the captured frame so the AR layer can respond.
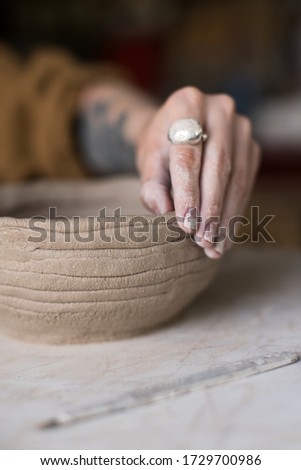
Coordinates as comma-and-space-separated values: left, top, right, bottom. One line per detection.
168, 118, 208, 145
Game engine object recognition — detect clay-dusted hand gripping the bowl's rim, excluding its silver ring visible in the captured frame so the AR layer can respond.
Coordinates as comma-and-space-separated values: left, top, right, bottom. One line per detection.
137, 87, 260, 259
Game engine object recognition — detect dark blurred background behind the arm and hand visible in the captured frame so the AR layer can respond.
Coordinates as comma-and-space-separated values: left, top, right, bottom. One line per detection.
0, 0, 301, 246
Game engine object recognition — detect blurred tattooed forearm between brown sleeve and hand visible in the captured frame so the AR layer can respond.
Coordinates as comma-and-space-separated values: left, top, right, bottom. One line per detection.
76, 84, 157, 174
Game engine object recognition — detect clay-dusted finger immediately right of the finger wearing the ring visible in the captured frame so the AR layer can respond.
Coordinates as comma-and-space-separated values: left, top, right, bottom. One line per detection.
195, 95, 235, 258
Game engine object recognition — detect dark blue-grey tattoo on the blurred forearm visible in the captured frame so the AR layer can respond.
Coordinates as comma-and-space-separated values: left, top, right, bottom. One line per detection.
76, 101, 135, 174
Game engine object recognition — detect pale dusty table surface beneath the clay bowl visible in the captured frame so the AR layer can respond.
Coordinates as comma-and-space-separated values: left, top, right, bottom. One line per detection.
0, 249, 301, 449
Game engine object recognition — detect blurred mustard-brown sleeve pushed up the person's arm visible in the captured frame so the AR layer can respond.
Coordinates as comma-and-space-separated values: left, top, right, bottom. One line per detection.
0, 46, 122, 182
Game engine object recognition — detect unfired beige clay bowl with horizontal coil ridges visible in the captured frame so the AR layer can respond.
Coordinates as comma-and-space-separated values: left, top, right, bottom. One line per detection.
0, 178, 217, 343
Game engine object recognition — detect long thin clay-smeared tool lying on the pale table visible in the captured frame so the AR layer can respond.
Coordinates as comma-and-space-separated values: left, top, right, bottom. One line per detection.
40, 352, 299, 429
